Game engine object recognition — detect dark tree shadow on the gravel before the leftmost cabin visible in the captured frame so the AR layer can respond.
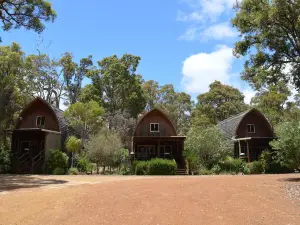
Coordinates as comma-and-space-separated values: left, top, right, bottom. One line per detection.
0, 175, 68, 192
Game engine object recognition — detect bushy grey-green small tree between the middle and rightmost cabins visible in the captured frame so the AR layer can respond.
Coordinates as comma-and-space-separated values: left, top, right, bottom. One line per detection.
184, 126, 233, 168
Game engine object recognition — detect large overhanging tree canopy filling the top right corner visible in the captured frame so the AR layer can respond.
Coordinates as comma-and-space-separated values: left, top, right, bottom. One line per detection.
232, 0, 300, 88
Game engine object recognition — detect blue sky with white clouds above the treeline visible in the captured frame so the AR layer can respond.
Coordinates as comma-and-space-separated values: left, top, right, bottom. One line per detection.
1, 0, 254, 102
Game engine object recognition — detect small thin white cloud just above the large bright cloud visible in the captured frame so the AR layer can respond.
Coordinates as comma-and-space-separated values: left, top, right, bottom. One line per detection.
201, 22, 237, 40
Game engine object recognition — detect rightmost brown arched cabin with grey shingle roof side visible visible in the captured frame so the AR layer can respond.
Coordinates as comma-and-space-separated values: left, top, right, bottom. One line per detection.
218, 108, 274, 162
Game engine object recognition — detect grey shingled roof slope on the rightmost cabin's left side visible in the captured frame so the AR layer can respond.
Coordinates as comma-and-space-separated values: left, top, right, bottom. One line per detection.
218, 108, 255, 138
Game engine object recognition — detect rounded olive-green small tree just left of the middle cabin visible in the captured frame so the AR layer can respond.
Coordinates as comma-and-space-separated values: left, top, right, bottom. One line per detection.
86, 130, 122, 173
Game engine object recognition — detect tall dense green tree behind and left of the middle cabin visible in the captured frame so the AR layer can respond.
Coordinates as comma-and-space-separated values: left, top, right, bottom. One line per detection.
90, 54, 146, 118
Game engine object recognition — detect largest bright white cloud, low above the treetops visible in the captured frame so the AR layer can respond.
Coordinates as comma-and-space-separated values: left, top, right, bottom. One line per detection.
182, 46, 233, 94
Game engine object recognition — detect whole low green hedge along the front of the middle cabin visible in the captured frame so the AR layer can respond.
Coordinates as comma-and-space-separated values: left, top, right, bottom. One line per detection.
133, 159, 177, 175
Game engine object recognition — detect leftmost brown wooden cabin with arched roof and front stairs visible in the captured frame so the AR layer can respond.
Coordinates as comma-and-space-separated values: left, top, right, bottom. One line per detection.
11, 98, 67, 173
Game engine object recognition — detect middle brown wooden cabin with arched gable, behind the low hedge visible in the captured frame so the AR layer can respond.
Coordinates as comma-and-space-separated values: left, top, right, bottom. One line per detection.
131, 109, 185, 169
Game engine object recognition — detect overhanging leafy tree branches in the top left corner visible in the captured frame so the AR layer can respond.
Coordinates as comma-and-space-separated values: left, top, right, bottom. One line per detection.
0, 0, 56, 40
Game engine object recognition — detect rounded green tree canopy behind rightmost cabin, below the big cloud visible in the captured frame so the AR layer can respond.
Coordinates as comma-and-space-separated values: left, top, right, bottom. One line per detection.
193, 81, 247, 124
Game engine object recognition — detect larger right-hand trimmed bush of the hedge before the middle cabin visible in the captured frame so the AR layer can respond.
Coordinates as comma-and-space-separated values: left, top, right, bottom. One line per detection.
148, 159, 177, 175
